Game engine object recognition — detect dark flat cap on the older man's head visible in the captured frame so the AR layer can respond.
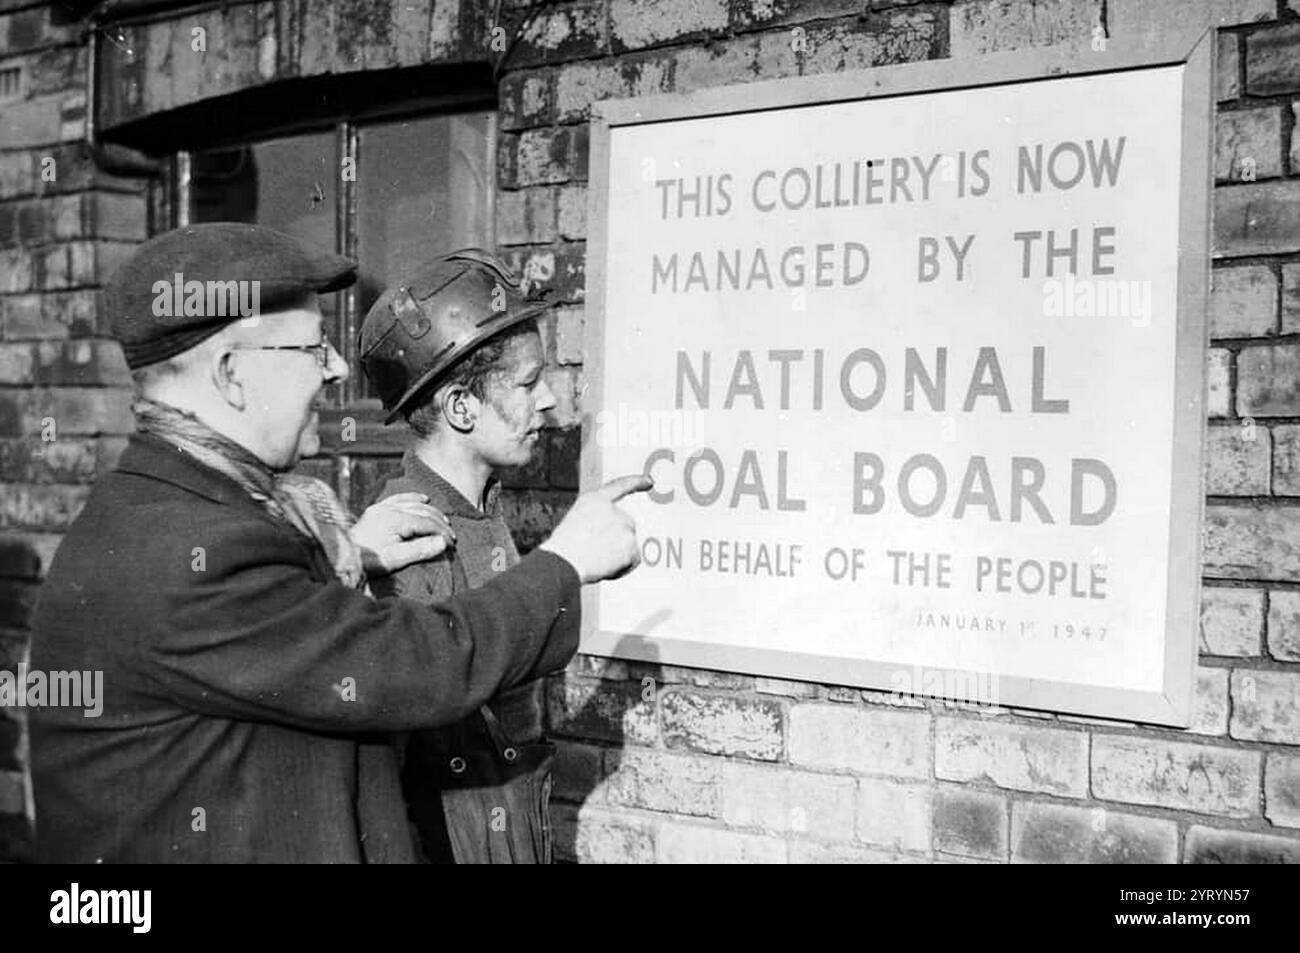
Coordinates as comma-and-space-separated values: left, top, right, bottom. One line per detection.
105, 222, 356, 371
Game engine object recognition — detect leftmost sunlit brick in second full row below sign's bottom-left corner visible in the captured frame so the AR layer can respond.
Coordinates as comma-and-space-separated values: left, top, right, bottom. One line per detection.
601, 748, 723, 818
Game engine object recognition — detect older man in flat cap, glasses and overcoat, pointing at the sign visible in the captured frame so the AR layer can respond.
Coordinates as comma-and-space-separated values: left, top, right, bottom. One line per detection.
31, 224, 647, 862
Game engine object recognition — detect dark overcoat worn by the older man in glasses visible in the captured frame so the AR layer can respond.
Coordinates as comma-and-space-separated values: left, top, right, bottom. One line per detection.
31, 434, 580, 862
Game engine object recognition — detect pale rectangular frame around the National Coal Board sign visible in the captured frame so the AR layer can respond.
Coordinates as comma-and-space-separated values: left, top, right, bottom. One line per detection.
579, 27, 1216, 727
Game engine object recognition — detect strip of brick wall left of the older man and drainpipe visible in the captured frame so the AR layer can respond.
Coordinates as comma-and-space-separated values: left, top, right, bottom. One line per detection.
0, 0, 148, 859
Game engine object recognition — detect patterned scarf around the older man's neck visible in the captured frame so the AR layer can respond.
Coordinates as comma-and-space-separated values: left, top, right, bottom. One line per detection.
131, 398, 365, 589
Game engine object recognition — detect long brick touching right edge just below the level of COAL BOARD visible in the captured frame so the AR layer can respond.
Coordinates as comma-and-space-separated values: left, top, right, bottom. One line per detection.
1203, 504, 1300, 582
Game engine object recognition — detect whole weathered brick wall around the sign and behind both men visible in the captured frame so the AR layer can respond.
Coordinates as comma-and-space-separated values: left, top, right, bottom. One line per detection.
0, 0, 1300, 862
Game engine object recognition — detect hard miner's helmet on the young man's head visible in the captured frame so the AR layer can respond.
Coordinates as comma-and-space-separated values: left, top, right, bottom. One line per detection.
358, 248, 549, 424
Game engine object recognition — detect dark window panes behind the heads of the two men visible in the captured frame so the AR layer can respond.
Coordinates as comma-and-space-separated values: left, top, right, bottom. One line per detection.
189, 109, 497, 407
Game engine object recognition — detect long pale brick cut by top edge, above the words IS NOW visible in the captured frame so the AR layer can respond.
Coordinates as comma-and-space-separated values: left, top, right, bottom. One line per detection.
949, 0, 1104, 60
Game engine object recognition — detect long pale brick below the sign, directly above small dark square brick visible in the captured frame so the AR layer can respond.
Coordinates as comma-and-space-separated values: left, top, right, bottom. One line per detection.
935, 718, 1088, 797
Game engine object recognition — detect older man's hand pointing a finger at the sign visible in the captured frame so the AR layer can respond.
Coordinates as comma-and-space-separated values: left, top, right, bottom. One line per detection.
538, 473, 654, 582
